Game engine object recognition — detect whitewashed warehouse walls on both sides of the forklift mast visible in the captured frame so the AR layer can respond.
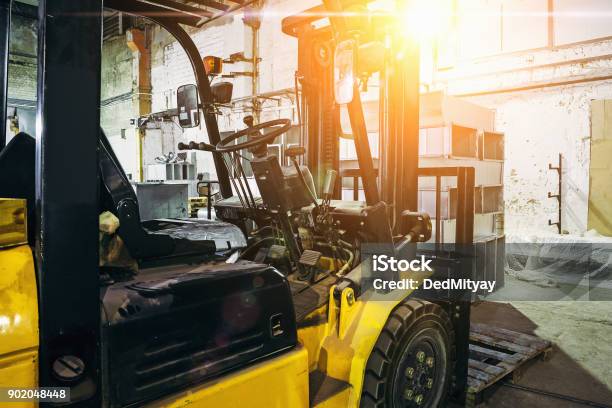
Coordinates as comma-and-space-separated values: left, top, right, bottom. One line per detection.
9, 0, 612, 234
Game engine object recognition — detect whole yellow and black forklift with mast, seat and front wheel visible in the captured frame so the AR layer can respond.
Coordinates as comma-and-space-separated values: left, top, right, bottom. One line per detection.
0, 0, 474, 407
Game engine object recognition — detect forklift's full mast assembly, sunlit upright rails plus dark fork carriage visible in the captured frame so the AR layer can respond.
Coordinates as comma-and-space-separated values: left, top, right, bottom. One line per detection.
282, 0, 474, 398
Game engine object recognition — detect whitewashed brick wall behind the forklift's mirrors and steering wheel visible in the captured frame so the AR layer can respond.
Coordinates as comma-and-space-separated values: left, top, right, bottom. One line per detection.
146, 0, 316, 180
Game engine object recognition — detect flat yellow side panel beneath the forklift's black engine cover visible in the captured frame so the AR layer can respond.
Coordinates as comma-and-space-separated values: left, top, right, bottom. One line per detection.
148, 347, 308, 408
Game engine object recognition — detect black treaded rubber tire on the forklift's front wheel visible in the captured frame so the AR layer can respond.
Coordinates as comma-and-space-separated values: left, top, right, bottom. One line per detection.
360, 299, 455, 408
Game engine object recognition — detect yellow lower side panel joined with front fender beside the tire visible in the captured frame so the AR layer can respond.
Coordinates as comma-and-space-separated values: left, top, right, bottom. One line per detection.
148, 278, 416, 408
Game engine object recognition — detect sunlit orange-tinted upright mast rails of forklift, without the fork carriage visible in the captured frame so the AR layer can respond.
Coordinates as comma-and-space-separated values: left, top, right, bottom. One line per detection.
283, 0, 419, 220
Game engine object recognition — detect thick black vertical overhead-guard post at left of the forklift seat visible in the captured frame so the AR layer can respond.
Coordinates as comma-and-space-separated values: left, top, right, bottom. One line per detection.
36, 0, 102, 406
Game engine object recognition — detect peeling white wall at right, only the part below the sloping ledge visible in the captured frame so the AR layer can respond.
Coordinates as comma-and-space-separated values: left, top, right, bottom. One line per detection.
472, 82, 612, 234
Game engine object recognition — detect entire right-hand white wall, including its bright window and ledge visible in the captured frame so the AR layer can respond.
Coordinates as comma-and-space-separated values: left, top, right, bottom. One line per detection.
424, 0, 612, 236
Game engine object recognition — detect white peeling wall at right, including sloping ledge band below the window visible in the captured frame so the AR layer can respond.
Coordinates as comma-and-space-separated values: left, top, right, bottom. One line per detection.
433, 40, 612, 234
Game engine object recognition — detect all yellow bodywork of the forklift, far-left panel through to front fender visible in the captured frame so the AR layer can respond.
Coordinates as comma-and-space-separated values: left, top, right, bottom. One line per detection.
0, 198, 418, 408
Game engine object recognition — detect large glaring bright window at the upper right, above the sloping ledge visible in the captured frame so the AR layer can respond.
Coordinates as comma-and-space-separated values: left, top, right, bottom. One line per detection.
438, 0, 612, 64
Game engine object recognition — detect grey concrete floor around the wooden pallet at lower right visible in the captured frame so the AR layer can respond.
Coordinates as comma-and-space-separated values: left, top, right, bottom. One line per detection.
472, 278, 612, 408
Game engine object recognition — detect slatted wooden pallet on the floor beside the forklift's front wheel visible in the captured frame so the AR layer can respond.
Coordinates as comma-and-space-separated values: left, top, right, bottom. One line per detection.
466, 323, 552, 407
